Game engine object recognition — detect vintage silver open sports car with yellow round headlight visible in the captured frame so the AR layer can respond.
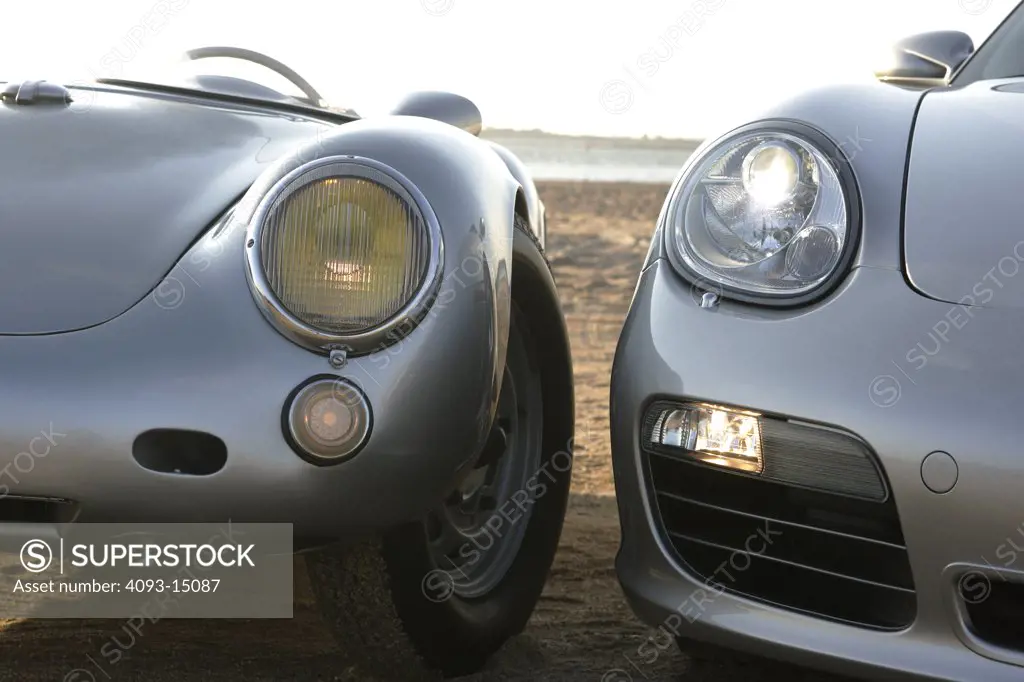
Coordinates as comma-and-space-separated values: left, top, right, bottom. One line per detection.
0, 47, 573, 679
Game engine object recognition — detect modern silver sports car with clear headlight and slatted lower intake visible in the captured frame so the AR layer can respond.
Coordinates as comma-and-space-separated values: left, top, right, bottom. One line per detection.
611, 7, 1024, 682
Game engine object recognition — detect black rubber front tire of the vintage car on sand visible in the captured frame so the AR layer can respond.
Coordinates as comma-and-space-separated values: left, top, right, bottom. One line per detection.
307, 229, 572, 680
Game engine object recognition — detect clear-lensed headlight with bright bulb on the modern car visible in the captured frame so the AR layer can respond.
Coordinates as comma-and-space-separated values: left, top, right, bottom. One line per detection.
665, 122, 858, 304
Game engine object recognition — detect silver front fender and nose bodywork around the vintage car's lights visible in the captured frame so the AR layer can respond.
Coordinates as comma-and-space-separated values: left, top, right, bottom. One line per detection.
0, 118, 524, 539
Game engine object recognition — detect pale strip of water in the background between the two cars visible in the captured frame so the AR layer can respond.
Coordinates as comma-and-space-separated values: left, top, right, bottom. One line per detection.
481, 130, 700, 183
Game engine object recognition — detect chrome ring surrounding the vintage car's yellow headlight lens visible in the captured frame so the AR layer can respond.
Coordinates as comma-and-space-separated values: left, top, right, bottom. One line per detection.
245, 156, 444, 355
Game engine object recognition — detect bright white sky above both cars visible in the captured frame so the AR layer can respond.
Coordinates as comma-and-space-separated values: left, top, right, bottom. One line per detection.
0, 0, 1018, 137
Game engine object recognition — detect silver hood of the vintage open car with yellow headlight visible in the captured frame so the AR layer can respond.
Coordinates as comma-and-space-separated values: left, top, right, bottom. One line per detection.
0, 83, 326, 334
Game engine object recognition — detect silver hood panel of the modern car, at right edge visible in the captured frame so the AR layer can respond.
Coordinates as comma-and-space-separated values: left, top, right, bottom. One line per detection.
904, 79, 1024, 308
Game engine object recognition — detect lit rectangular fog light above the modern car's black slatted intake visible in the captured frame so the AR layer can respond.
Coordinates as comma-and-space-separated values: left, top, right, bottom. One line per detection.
650, 403, 764, 474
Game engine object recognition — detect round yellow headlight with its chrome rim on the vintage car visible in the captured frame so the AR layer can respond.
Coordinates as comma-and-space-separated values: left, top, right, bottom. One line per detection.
247, 158, 441, 352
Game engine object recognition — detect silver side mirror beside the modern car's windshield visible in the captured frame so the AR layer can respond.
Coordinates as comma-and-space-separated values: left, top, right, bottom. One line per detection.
874, 31, 974, 89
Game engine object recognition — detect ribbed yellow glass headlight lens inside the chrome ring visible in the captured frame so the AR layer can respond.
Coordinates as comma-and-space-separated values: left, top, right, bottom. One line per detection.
261, 176, 430, 334
